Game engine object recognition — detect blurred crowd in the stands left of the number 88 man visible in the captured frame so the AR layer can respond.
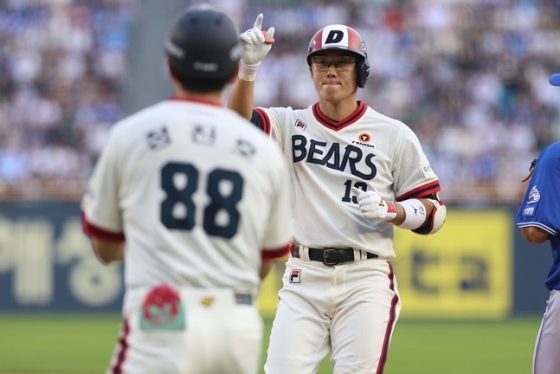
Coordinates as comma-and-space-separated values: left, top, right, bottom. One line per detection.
0, 0, 133, 200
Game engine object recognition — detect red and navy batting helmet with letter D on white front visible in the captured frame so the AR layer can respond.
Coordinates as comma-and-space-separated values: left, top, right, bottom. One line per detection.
307, 25, 370, 87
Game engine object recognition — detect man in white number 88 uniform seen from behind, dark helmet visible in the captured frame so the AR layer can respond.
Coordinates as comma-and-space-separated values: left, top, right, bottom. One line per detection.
82, 7, 292, 374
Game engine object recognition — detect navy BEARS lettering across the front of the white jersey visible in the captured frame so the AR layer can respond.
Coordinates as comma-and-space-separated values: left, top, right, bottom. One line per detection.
292, 135, 377, 180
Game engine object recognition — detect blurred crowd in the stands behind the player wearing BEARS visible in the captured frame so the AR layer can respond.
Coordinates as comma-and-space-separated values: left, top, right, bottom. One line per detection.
241, 0, 560, 205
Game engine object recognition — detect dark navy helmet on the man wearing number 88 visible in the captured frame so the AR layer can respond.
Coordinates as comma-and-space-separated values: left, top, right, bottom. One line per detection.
165, 6, 241, 84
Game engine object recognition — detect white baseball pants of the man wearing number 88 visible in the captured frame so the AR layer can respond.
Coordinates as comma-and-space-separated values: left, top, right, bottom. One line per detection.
107, 289, 263, 374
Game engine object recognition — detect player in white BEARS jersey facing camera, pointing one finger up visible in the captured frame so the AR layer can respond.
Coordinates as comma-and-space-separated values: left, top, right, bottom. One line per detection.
229, 14, 446, 374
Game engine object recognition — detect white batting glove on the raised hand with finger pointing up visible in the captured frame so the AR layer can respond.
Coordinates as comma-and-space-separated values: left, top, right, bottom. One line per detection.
239, 13, 274, 81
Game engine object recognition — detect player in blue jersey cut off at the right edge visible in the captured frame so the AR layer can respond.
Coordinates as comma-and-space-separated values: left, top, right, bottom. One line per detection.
516, 74, 560, 374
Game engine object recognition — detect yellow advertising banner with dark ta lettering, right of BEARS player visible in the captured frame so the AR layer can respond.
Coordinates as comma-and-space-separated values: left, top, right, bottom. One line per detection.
392, 210, 513, 318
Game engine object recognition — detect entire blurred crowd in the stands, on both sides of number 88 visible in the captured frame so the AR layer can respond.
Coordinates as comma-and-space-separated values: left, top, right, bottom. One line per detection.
0, 0, 560, 205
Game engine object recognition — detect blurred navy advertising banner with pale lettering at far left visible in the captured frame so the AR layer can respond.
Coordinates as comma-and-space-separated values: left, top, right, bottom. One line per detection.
0, 203, 123, 311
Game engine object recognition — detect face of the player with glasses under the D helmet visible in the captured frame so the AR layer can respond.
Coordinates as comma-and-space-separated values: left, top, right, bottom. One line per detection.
309, 51, 357, 102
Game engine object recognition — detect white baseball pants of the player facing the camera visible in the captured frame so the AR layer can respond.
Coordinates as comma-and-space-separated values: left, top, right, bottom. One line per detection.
265, 257, 401, 374
